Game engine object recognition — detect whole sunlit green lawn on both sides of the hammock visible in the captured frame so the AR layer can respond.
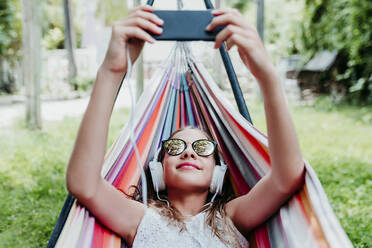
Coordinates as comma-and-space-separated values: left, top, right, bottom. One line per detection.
0, 98, 372, 248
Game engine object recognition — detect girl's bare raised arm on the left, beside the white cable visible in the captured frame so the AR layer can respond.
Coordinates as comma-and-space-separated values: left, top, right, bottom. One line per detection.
66, 6, 162, 244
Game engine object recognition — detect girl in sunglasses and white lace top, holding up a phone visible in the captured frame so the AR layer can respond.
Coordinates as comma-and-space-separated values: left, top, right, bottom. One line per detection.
66, 6, 304, 247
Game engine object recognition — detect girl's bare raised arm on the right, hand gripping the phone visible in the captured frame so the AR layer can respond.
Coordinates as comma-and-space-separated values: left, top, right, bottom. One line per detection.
208, 10, 304, 232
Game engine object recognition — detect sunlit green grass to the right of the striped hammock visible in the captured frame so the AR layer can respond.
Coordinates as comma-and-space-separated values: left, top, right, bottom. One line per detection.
250, 97, 372, 248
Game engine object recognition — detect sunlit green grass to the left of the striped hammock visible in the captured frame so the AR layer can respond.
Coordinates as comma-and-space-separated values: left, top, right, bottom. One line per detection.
0, 110, 128, 248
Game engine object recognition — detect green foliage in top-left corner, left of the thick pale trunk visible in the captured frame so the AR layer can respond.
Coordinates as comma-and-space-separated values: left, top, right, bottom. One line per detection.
0, 0, 22, 62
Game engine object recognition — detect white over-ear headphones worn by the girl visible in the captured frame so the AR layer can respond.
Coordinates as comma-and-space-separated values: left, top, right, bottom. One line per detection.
149, 149, 227, 195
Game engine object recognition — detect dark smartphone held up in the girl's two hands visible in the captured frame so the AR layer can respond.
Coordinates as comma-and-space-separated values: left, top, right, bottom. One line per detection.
151, 10, 224, 41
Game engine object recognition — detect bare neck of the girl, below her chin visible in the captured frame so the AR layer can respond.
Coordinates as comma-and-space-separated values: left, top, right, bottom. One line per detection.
168, 189, 208, 217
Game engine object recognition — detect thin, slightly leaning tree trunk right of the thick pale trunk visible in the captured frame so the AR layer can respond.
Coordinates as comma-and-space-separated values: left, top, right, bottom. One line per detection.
63, 0, 78, 90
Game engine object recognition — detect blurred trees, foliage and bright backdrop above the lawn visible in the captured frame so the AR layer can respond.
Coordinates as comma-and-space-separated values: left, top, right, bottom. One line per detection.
0, 0, 372, 127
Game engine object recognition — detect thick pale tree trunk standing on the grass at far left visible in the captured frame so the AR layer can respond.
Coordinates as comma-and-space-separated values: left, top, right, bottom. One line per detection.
22, 0, 41, 129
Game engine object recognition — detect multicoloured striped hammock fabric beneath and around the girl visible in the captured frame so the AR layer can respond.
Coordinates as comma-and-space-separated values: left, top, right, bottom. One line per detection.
48, 44, 352, 248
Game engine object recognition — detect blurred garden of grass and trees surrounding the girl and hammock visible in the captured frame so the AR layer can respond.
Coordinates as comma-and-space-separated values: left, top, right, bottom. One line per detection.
0, 0, 372, 247
